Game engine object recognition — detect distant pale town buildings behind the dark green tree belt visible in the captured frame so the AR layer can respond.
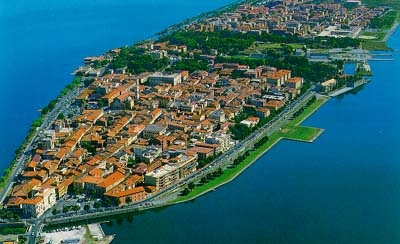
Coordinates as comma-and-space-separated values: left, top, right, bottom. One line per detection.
187, 0, 385, 37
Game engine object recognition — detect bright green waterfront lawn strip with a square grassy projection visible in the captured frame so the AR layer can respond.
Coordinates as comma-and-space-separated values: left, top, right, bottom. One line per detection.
169, 98, 327, 204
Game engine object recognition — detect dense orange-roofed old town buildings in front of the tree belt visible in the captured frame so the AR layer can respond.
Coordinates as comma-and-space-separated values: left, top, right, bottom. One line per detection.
5, 59, 303, 217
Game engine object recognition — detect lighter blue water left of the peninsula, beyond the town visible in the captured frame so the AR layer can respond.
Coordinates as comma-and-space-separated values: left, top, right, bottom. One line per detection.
0, 0, 234, 172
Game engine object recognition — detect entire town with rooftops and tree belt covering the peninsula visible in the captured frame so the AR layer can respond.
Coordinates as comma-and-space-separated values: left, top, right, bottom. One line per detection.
0, 0, 396, 242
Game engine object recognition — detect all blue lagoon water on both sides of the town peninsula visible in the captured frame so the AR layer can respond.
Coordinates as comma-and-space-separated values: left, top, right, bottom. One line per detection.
0, 0, 400, 244
